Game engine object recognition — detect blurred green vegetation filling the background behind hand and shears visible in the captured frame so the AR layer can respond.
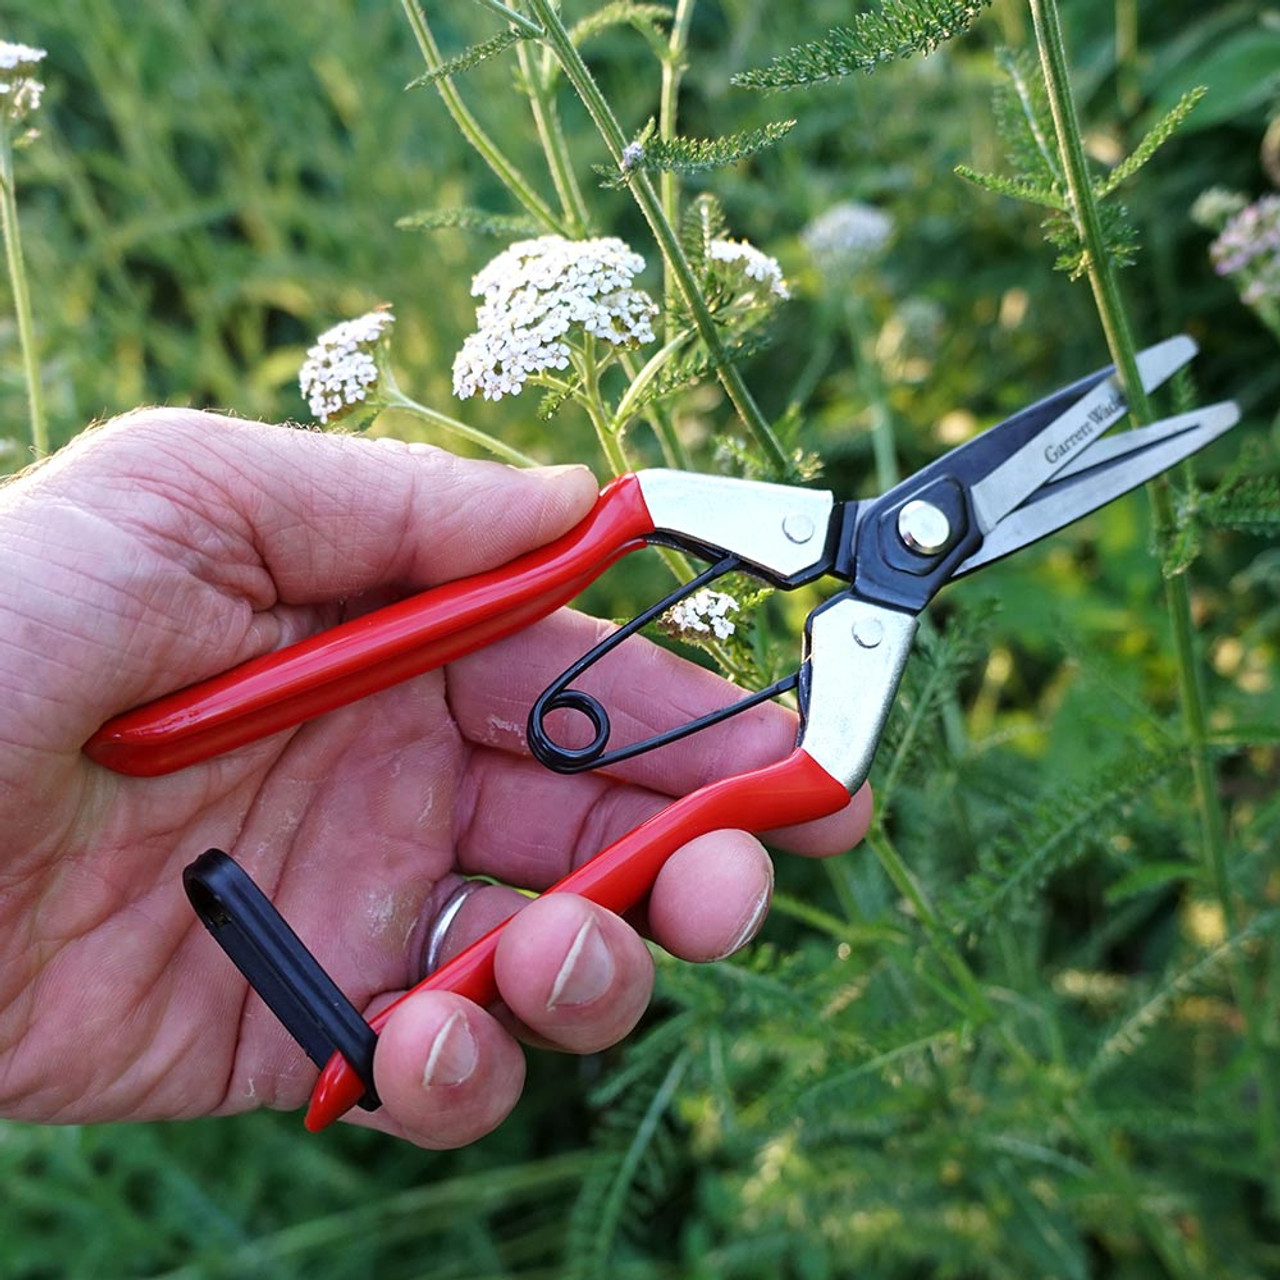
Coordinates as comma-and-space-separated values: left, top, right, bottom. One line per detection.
0, 0, 1280, 1280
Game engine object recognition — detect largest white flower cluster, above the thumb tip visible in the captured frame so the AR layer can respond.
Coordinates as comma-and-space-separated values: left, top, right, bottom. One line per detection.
453, 236, 658, 401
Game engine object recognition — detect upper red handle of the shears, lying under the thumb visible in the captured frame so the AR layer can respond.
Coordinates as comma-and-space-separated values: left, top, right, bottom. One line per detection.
84, 475, 653, 777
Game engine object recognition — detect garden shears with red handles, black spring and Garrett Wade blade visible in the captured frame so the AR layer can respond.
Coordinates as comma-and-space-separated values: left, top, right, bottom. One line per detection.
84, 337, 1239, 1130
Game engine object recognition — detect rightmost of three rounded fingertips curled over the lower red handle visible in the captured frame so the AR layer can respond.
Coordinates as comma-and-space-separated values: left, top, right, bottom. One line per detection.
648, 831, 773, 961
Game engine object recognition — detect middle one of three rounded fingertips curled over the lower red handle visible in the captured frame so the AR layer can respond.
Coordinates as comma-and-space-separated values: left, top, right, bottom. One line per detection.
494, 893, 653, 1053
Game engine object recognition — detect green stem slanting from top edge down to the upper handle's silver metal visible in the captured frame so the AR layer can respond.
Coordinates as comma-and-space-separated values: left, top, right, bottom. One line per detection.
530, 0, 787, 475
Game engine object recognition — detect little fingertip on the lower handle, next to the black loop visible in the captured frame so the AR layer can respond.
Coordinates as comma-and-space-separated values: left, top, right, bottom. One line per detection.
374, 991, 525, 1149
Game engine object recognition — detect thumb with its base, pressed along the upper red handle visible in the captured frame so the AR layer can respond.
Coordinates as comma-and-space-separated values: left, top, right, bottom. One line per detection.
68, 410, 596, 607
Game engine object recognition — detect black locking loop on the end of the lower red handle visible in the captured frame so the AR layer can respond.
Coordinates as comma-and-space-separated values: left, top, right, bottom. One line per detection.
182, 849, 381, 1111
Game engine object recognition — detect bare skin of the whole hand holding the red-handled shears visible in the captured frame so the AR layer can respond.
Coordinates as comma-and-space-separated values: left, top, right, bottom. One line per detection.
0, 410, 870, 1147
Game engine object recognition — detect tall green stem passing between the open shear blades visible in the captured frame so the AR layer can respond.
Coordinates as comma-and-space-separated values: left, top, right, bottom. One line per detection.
1030, 0, 1280, 1187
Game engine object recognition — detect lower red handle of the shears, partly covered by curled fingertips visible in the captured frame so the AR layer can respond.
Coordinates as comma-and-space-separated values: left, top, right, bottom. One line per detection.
306, 748, 849, 1133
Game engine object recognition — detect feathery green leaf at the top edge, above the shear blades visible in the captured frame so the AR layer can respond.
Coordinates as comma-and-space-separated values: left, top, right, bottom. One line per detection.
733, 0, 991, 90
